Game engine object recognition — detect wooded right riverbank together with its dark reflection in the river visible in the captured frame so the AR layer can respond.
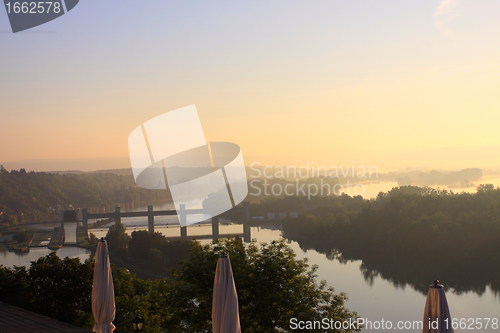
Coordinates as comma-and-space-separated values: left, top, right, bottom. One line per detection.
283, 185, 500, 294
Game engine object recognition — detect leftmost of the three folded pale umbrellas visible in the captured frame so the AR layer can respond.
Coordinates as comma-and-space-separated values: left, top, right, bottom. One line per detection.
92, 239, 116, 333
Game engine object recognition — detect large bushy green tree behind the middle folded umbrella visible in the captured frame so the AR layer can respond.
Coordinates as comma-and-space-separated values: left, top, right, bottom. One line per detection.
164, 238, 357, 333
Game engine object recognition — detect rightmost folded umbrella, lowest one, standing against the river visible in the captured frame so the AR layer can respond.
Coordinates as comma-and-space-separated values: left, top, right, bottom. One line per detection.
422, 280, 454, 333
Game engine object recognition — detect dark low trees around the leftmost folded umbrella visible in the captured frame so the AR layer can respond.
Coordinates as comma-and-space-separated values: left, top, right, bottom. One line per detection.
0, 252, 165, 333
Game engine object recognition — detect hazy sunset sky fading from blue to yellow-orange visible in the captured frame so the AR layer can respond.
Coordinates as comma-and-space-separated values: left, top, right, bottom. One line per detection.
0, 0, 500, 170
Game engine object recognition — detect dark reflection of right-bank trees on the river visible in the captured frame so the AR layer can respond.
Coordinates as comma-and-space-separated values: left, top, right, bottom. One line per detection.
285, 227, 500, 296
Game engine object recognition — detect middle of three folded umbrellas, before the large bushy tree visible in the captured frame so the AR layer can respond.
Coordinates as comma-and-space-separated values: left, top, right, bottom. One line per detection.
212, 253, 241, 333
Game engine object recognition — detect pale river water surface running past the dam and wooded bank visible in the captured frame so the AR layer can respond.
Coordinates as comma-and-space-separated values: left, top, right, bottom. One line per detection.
0, 184, 500, 333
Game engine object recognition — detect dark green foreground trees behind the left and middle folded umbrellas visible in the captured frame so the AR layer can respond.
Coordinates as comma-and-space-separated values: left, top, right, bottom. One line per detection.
0, 238, 359, 333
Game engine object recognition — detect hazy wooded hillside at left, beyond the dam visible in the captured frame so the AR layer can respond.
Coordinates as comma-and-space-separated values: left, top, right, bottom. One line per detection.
0, 167, 169, 225
